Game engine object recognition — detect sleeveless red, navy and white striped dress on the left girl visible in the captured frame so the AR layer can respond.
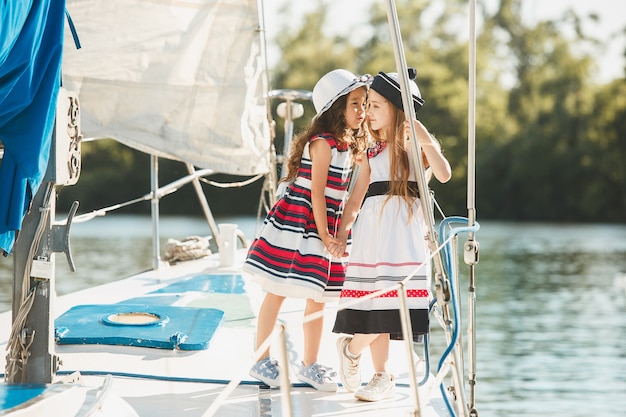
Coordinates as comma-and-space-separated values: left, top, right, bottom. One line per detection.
243, 134, 352, 302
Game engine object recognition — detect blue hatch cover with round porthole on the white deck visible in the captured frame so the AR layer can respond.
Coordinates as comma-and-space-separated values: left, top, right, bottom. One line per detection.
54, 304, 224, 350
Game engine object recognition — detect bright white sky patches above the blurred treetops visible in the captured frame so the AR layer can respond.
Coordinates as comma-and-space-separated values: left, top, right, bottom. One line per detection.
265, 0, 626, 81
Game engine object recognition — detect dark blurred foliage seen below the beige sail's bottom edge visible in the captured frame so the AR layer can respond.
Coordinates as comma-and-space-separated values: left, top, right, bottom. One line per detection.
57, 139, 263, 216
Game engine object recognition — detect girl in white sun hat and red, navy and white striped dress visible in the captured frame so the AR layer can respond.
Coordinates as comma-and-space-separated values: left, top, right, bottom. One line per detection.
243, 69, 367, 391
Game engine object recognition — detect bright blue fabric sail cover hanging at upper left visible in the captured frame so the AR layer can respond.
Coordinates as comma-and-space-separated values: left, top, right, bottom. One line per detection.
0, 0, 65, 254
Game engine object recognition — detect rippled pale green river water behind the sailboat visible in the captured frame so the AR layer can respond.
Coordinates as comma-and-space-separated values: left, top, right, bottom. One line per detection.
0, 215, 626, 417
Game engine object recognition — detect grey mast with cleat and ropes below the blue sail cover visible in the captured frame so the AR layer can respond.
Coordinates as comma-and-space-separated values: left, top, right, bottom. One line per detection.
5, 88, 82, 384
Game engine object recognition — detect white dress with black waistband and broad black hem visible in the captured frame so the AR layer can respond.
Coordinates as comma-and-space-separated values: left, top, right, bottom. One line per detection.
333, 143, 431, 340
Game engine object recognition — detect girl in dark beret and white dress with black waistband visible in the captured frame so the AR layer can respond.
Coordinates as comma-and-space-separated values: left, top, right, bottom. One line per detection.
333, 69, 451, 401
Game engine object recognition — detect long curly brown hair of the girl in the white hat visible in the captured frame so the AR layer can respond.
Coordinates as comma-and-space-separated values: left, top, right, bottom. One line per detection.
282, 87, 367, 181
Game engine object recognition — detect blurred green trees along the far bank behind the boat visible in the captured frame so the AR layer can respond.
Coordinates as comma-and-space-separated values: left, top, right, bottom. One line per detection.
59, 0, 626, 222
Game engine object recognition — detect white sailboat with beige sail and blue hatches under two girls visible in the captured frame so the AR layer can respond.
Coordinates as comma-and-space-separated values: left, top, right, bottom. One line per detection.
0, 0, 478, 417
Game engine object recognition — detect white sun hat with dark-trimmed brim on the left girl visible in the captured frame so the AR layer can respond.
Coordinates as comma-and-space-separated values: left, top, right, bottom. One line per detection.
313, 69, 371, 117
